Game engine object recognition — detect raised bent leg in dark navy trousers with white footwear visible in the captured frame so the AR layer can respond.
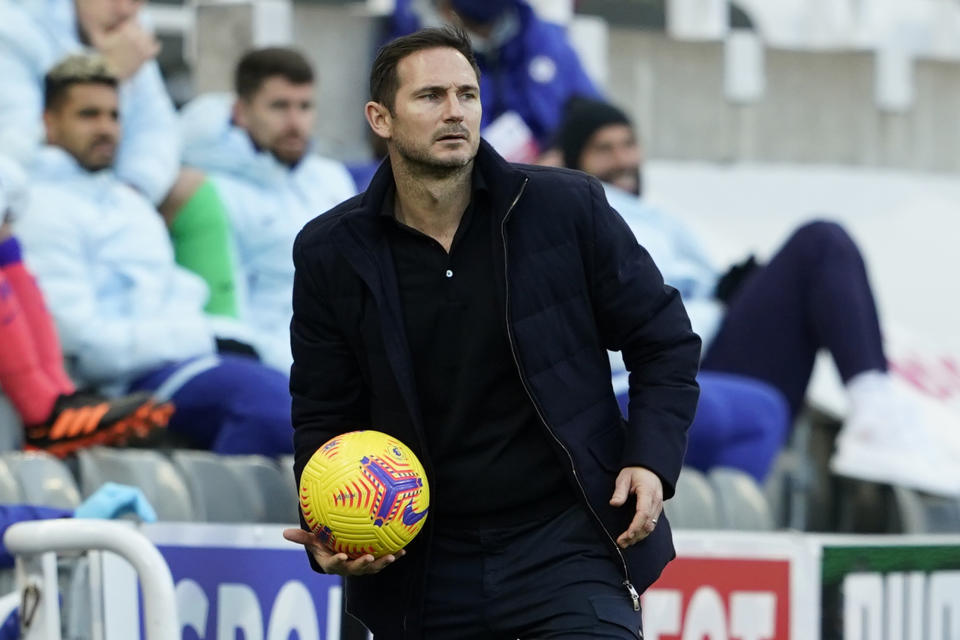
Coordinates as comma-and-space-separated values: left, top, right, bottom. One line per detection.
702, 222, 960, 495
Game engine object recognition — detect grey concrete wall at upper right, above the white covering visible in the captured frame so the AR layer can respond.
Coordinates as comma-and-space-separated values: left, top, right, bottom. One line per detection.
608, 28, 960, 171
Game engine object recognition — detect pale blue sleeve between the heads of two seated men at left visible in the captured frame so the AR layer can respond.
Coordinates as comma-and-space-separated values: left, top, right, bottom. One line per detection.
116, 61, 180, 205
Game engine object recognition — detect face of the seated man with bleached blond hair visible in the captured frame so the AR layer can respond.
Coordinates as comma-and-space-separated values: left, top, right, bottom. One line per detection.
43, 83, 120, 171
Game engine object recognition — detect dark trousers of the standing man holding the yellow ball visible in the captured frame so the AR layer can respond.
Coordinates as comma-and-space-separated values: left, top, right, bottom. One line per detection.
416, 504, 642, 640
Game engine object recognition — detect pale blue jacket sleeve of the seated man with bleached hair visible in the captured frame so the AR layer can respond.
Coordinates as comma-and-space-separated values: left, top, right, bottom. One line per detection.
16, 196, 214, 383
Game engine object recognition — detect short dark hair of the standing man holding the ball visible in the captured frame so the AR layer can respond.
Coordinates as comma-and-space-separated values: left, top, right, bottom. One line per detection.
370, 26, 480, 113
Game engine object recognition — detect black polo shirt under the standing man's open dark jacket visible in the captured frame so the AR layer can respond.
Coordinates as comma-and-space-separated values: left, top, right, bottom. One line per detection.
381, 170, 574, 528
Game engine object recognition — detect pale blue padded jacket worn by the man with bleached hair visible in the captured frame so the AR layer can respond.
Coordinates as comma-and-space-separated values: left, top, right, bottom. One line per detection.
14, 147, 215, 385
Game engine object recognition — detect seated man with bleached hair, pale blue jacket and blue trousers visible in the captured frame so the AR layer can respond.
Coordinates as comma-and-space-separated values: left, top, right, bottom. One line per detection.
15, 55, 291, 455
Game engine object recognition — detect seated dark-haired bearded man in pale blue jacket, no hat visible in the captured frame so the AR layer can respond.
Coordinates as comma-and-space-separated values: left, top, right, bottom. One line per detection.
181, 48, 356, 373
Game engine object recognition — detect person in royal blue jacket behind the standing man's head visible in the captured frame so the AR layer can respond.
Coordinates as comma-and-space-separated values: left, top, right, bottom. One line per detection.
389, 0, 599, 162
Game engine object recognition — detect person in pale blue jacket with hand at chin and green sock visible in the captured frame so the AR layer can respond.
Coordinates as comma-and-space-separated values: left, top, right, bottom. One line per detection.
0, 0, 244, 316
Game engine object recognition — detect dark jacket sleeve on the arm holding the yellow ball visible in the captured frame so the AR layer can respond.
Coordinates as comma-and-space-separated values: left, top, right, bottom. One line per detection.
290, 232, 370, 571
